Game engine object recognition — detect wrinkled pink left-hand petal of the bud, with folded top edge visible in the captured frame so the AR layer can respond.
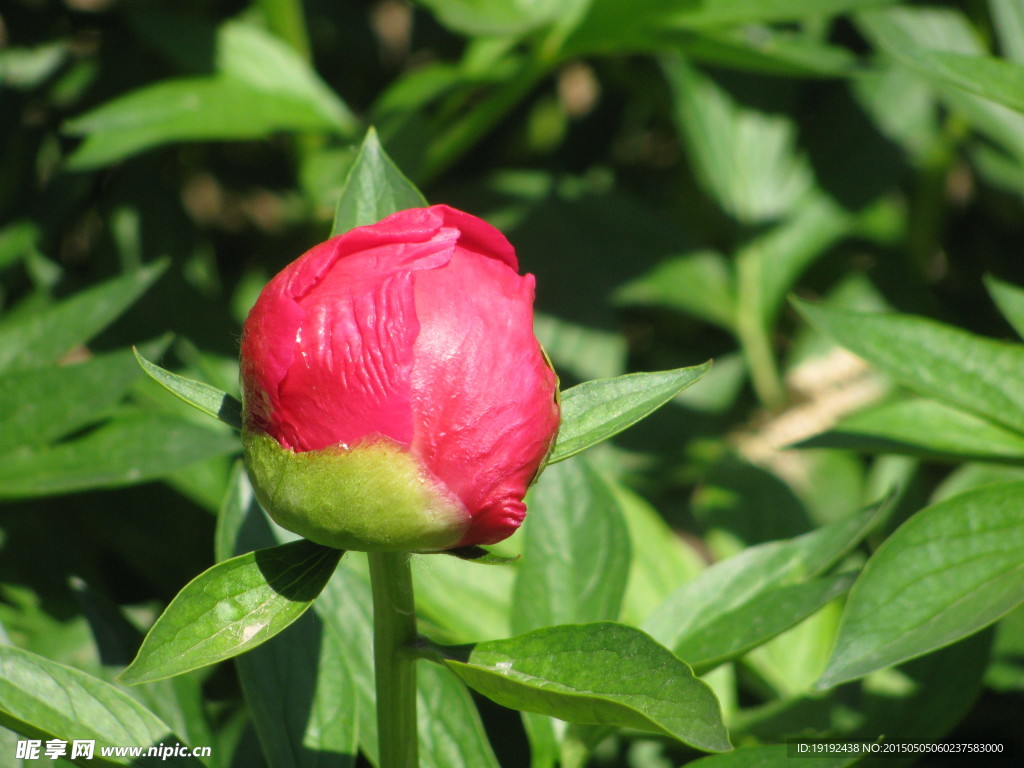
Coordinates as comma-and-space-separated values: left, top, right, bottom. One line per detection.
243, 209, 459, 452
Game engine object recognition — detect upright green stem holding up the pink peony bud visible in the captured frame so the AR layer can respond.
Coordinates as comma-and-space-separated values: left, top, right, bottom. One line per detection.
369, 552, 419, 768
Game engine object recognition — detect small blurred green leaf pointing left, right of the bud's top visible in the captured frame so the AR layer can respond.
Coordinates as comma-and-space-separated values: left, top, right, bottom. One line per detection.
615, 251, 736, 331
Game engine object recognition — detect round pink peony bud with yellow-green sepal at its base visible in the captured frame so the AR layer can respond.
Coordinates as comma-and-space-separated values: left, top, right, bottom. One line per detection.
242, 206, 558, 551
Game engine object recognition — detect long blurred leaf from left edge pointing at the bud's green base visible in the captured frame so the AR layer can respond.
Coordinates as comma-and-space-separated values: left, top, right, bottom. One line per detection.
0, 413, 239, 499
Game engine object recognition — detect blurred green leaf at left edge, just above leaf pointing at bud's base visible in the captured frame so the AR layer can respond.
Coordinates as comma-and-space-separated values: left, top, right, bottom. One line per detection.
0, 342, 166, 454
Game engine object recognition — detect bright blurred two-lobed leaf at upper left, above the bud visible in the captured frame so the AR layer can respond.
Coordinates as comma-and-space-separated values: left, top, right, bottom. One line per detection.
65, 22, 355, 169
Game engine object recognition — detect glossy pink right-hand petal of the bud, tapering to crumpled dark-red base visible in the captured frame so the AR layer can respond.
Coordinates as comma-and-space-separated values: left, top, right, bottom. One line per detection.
413, 249, 558, 544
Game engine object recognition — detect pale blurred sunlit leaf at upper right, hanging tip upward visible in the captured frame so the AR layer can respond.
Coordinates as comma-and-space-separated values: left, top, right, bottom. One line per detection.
662, 56, 813, 224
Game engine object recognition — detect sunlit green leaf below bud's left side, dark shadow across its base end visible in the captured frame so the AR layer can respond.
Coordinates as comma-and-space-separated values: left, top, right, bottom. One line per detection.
121, 540, 342, 685
